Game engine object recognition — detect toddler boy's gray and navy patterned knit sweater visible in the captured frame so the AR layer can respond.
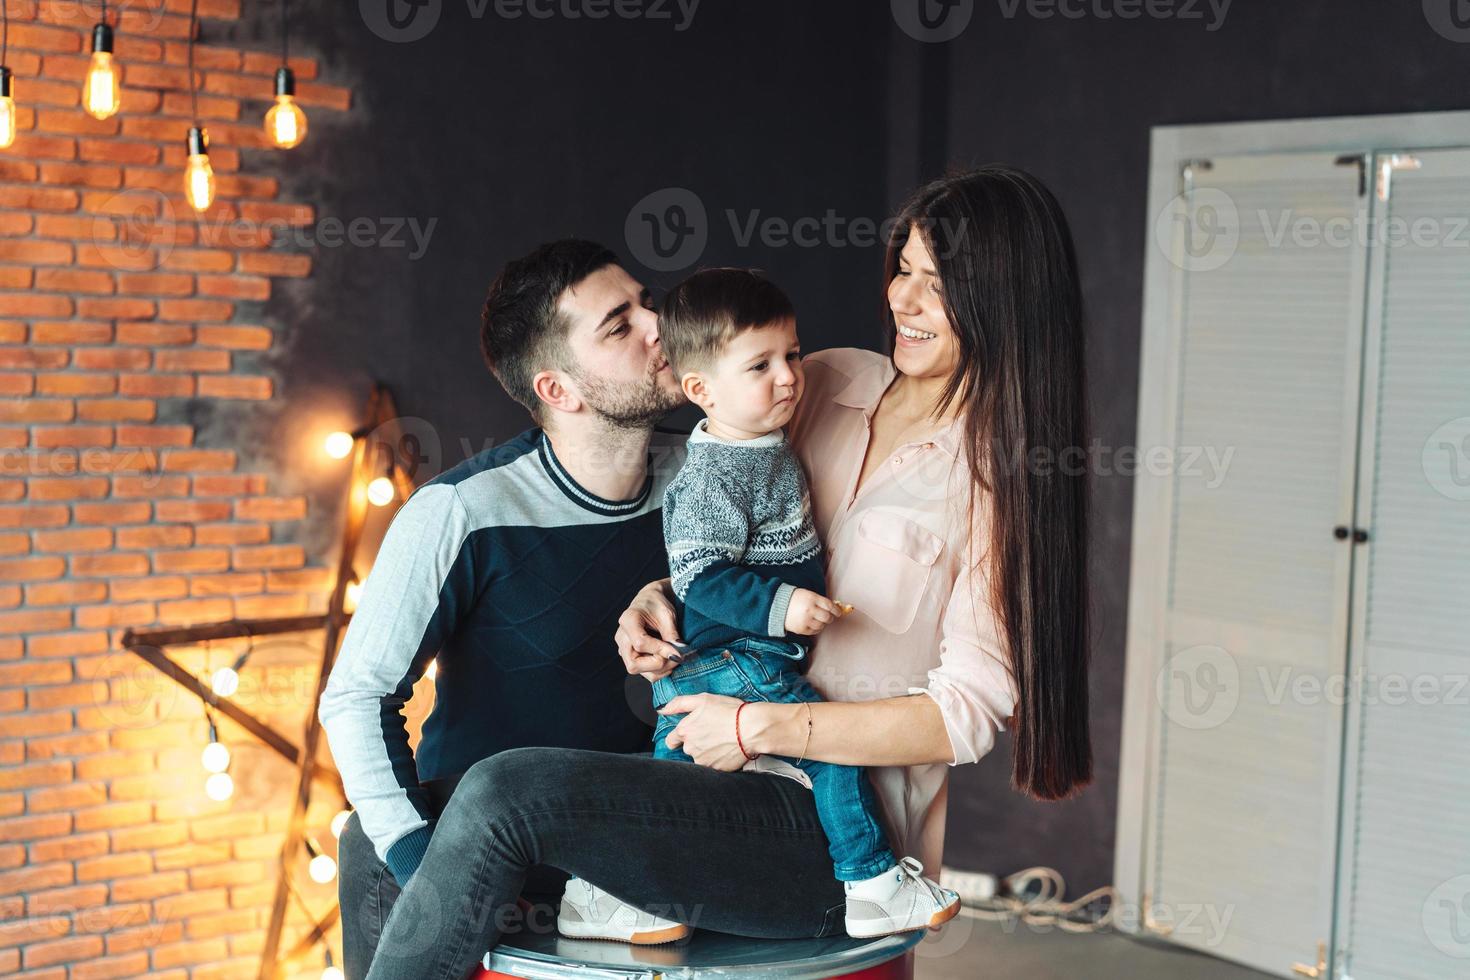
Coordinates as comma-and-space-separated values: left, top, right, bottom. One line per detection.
663, 420, 826, 649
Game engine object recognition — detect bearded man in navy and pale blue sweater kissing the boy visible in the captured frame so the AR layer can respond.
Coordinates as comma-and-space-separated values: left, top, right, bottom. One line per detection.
319, 239, 685, 977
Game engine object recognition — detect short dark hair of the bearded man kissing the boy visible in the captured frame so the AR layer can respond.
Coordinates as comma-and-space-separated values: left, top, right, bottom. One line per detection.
479, 238, 617, 422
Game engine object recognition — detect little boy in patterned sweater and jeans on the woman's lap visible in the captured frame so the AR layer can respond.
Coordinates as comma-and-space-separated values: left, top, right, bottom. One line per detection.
573, 269, 960, 937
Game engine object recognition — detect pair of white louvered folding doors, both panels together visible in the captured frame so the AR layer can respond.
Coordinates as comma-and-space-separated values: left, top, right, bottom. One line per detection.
1119, 138, 1470, 980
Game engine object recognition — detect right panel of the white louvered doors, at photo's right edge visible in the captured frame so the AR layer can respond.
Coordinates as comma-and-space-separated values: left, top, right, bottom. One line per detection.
1336, 150, 1470, 980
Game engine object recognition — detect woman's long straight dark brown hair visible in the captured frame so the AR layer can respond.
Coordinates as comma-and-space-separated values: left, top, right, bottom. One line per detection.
886, 166, 1092, 799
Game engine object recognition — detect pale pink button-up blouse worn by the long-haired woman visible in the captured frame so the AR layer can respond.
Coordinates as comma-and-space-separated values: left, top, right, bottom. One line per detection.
786, 348, 1016, 873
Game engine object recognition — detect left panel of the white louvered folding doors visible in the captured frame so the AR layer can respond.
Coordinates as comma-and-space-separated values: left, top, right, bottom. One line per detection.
1144, 154, 1367, 974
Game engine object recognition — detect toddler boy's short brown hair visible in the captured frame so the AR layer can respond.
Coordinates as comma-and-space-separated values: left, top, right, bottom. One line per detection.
659, 269, 797, 376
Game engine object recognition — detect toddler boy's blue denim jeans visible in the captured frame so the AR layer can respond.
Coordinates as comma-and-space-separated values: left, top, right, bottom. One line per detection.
653, 636, 897, 882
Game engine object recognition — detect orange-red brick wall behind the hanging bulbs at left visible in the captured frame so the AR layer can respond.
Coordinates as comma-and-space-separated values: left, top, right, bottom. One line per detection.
0, 0, 350, 979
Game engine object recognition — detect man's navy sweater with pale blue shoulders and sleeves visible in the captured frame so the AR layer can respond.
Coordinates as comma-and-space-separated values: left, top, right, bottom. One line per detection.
320, 429, 684, 883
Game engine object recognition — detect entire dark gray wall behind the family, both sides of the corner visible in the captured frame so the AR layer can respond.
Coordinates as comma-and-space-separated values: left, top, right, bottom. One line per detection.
213, 0, 1470, 895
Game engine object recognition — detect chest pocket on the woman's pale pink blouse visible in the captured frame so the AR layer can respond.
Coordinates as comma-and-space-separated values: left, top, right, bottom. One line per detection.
832, 510, 944, 633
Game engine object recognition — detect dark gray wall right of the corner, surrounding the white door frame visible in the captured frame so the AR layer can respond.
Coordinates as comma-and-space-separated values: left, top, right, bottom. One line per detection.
932, 0, 1470, 895
